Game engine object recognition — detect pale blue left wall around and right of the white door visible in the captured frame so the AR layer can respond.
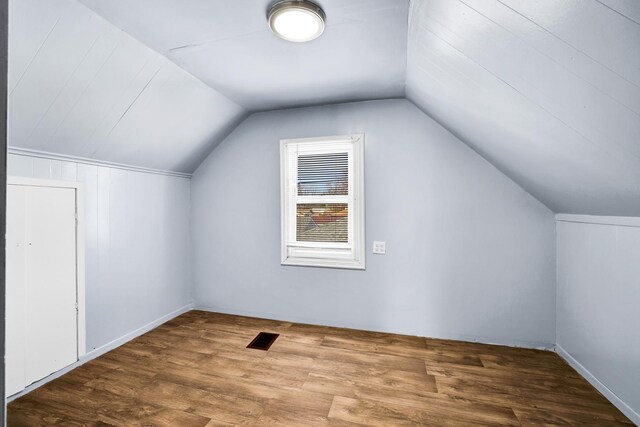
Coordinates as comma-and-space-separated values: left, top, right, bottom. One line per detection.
7, 154, 190, 352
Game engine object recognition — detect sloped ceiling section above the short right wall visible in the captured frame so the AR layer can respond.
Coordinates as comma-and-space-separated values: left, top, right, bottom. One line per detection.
406, 0, 640, 216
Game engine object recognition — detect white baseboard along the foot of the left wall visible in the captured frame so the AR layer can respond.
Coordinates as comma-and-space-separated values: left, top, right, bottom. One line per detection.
6, 304, 193, 403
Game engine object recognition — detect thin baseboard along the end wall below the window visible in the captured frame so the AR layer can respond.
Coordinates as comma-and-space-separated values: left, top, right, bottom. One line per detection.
194, 304, 555, 351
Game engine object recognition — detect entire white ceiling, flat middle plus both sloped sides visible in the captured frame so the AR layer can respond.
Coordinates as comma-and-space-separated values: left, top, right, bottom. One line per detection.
9, 0, 640, 216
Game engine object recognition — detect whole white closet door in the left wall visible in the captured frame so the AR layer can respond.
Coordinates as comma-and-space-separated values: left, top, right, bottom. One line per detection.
6, 185, 78, 396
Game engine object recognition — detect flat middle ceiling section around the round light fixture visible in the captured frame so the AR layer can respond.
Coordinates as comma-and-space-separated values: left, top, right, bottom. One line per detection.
80, 0, 409, 111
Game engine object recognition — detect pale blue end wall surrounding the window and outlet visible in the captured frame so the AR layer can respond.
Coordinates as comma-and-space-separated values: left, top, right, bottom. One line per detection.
191, 100, 555, 346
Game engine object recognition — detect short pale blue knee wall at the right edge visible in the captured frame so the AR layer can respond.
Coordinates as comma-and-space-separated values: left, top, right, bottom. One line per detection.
557, 215, 640, 423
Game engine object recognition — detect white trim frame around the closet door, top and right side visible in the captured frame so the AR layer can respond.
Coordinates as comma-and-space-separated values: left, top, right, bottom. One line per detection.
7, 176, 87, 360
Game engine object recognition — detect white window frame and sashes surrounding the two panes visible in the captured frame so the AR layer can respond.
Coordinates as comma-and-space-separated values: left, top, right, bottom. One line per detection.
280, 134, 365, 270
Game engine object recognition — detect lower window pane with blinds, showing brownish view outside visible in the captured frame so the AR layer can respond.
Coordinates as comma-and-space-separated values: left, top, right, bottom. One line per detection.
296, 203, 349, 243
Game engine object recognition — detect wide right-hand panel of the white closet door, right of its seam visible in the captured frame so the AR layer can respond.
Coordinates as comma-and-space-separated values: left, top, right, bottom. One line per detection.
25, 187, 78, 384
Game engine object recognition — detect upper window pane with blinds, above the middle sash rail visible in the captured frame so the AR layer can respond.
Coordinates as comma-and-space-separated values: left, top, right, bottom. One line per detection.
298, 153, 349, 196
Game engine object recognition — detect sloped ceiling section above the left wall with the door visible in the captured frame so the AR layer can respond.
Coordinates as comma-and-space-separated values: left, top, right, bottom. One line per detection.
8, 0, 245, 173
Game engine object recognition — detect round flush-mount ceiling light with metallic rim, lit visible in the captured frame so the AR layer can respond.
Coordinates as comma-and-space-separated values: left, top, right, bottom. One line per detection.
267, 0, 326, 42
